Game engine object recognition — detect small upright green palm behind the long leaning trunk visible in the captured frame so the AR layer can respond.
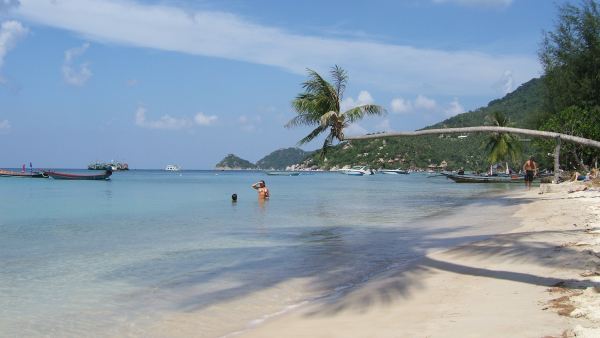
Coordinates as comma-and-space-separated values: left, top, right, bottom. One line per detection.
485, 112, 521, 168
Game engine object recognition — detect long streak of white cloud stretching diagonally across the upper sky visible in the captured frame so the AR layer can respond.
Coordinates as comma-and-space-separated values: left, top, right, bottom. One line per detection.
17, 0, 540, 95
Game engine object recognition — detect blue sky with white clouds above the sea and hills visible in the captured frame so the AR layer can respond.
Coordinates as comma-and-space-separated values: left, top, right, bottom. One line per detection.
0, 0, 576, 169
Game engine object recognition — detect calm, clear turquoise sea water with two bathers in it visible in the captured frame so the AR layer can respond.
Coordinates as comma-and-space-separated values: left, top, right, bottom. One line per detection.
0, 171, 506, 337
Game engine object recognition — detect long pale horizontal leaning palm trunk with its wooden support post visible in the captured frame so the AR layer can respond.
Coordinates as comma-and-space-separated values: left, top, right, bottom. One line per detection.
346, 126, 600, 183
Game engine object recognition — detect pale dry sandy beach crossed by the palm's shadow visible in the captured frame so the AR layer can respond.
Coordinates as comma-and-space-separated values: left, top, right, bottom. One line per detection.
239, 188, 600, 337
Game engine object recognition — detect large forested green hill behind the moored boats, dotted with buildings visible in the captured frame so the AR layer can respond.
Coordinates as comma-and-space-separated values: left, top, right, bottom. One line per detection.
305, 79, 551, 170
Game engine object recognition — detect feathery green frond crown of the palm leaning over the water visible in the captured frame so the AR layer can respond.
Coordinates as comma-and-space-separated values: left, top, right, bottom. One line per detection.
285, 65, 385, 156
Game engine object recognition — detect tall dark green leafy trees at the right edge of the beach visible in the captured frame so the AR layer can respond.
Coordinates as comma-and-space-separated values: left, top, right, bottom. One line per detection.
538, 0, 600, 168
